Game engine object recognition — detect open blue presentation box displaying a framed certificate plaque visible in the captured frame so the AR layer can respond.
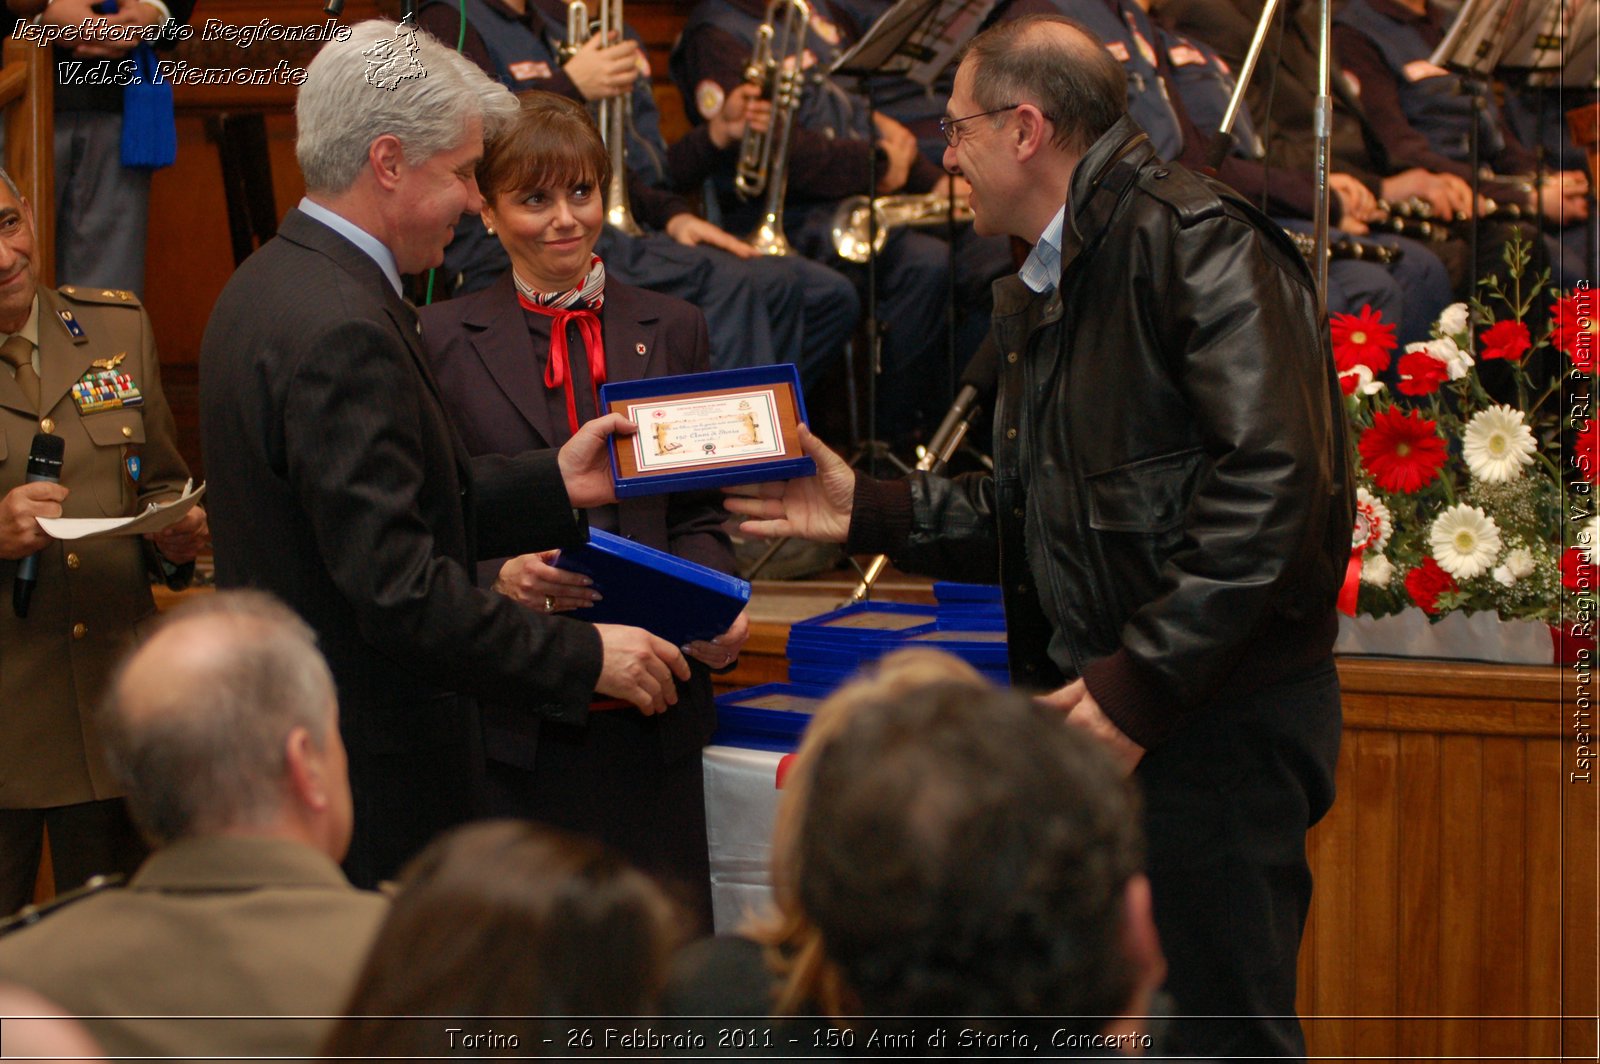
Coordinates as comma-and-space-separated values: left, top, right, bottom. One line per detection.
600, 362, 816, 499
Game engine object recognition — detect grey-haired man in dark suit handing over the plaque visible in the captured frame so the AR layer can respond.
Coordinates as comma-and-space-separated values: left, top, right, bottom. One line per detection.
200, 21, 690, 885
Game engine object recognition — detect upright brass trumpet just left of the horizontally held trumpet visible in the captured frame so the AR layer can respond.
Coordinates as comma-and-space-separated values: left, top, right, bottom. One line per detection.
733, 0, 811, 254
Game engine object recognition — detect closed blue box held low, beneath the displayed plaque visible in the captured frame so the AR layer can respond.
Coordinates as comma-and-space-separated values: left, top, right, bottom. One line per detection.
555, 528, 750, 646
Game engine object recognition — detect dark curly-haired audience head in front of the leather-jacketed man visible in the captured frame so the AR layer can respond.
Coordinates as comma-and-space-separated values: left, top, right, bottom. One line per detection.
797, 685, 1163, 1034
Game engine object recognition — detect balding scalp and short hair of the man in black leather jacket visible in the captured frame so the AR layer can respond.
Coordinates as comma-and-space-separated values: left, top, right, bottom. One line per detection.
962, 14, 1128, 154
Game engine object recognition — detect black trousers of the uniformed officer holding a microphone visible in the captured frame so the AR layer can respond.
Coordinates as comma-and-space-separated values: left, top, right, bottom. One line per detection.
0, 798, 149, 917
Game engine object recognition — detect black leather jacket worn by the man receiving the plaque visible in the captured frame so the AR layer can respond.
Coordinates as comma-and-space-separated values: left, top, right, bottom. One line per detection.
851, 118, 1354, 747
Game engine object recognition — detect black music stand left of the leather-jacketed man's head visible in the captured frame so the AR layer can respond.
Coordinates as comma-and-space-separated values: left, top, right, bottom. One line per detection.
827, 0, 995, 475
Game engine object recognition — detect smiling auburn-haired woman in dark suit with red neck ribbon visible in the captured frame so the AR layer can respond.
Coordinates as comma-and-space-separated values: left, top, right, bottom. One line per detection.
421, 90, 749, 931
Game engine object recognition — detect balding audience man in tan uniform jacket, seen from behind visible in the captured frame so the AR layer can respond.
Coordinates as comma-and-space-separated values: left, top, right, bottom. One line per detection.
0, 592, 387, 1058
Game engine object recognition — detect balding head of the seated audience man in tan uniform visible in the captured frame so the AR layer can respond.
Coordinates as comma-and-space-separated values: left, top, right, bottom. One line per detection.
101, 590, 352, 861
